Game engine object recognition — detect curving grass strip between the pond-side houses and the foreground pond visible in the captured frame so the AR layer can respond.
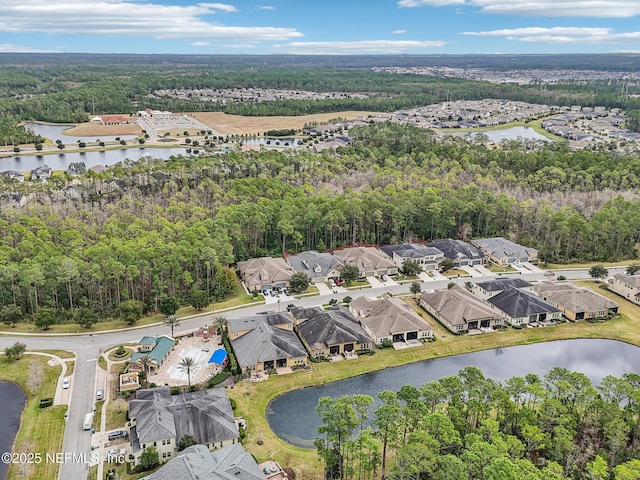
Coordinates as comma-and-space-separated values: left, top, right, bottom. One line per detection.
228, 282, 640, 480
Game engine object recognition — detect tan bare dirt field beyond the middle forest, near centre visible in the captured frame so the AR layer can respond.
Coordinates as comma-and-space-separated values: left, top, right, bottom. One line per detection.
191, 111, 377, 135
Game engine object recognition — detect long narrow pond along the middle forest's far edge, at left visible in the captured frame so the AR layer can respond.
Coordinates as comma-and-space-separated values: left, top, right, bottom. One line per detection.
0, 147, 188, 172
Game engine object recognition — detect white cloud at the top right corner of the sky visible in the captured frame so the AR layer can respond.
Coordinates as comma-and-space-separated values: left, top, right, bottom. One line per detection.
398, 0, 640, 18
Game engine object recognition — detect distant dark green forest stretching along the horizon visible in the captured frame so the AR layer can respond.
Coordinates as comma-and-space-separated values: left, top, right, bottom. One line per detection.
0, 55, 640, 145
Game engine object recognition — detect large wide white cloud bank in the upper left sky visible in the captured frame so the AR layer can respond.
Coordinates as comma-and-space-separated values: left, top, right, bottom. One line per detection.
0, 0, 303, 41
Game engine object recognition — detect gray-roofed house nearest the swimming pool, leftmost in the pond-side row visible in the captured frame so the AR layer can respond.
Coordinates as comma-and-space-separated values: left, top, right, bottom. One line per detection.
227, 312, 307, 371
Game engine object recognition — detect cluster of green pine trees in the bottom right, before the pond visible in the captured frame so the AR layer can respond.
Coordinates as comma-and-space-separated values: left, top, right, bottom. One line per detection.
314, 367, 640, 480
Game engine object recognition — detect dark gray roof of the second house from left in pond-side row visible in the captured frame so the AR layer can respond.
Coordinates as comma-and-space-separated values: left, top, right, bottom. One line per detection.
291, 305, 371, 348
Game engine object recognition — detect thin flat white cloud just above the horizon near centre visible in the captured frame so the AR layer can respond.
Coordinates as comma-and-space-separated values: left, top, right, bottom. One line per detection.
274, 40, 446, 55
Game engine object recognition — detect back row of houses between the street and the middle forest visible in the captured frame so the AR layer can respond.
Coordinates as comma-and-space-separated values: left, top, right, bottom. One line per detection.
238, 237, 538, 291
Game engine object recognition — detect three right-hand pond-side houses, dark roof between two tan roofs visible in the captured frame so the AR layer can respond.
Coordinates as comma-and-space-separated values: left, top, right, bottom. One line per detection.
419, 278, 620, 333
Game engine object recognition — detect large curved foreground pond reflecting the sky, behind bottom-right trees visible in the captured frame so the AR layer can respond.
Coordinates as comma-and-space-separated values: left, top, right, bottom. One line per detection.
267, 340, 640, 448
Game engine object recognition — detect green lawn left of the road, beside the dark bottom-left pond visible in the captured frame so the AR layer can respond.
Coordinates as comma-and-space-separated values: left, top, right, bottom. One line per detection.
0, 355, 67, 480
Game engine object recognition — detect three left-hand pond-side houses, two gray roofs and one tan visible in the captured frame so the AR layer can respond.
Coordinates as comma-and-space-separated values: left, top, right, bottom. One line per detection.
227, 295, 433, 371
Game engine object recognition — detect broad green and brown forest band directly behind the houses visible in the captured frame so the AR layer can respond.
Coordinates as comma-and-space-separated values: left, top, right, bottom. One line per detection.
0, 123, 640, 323
